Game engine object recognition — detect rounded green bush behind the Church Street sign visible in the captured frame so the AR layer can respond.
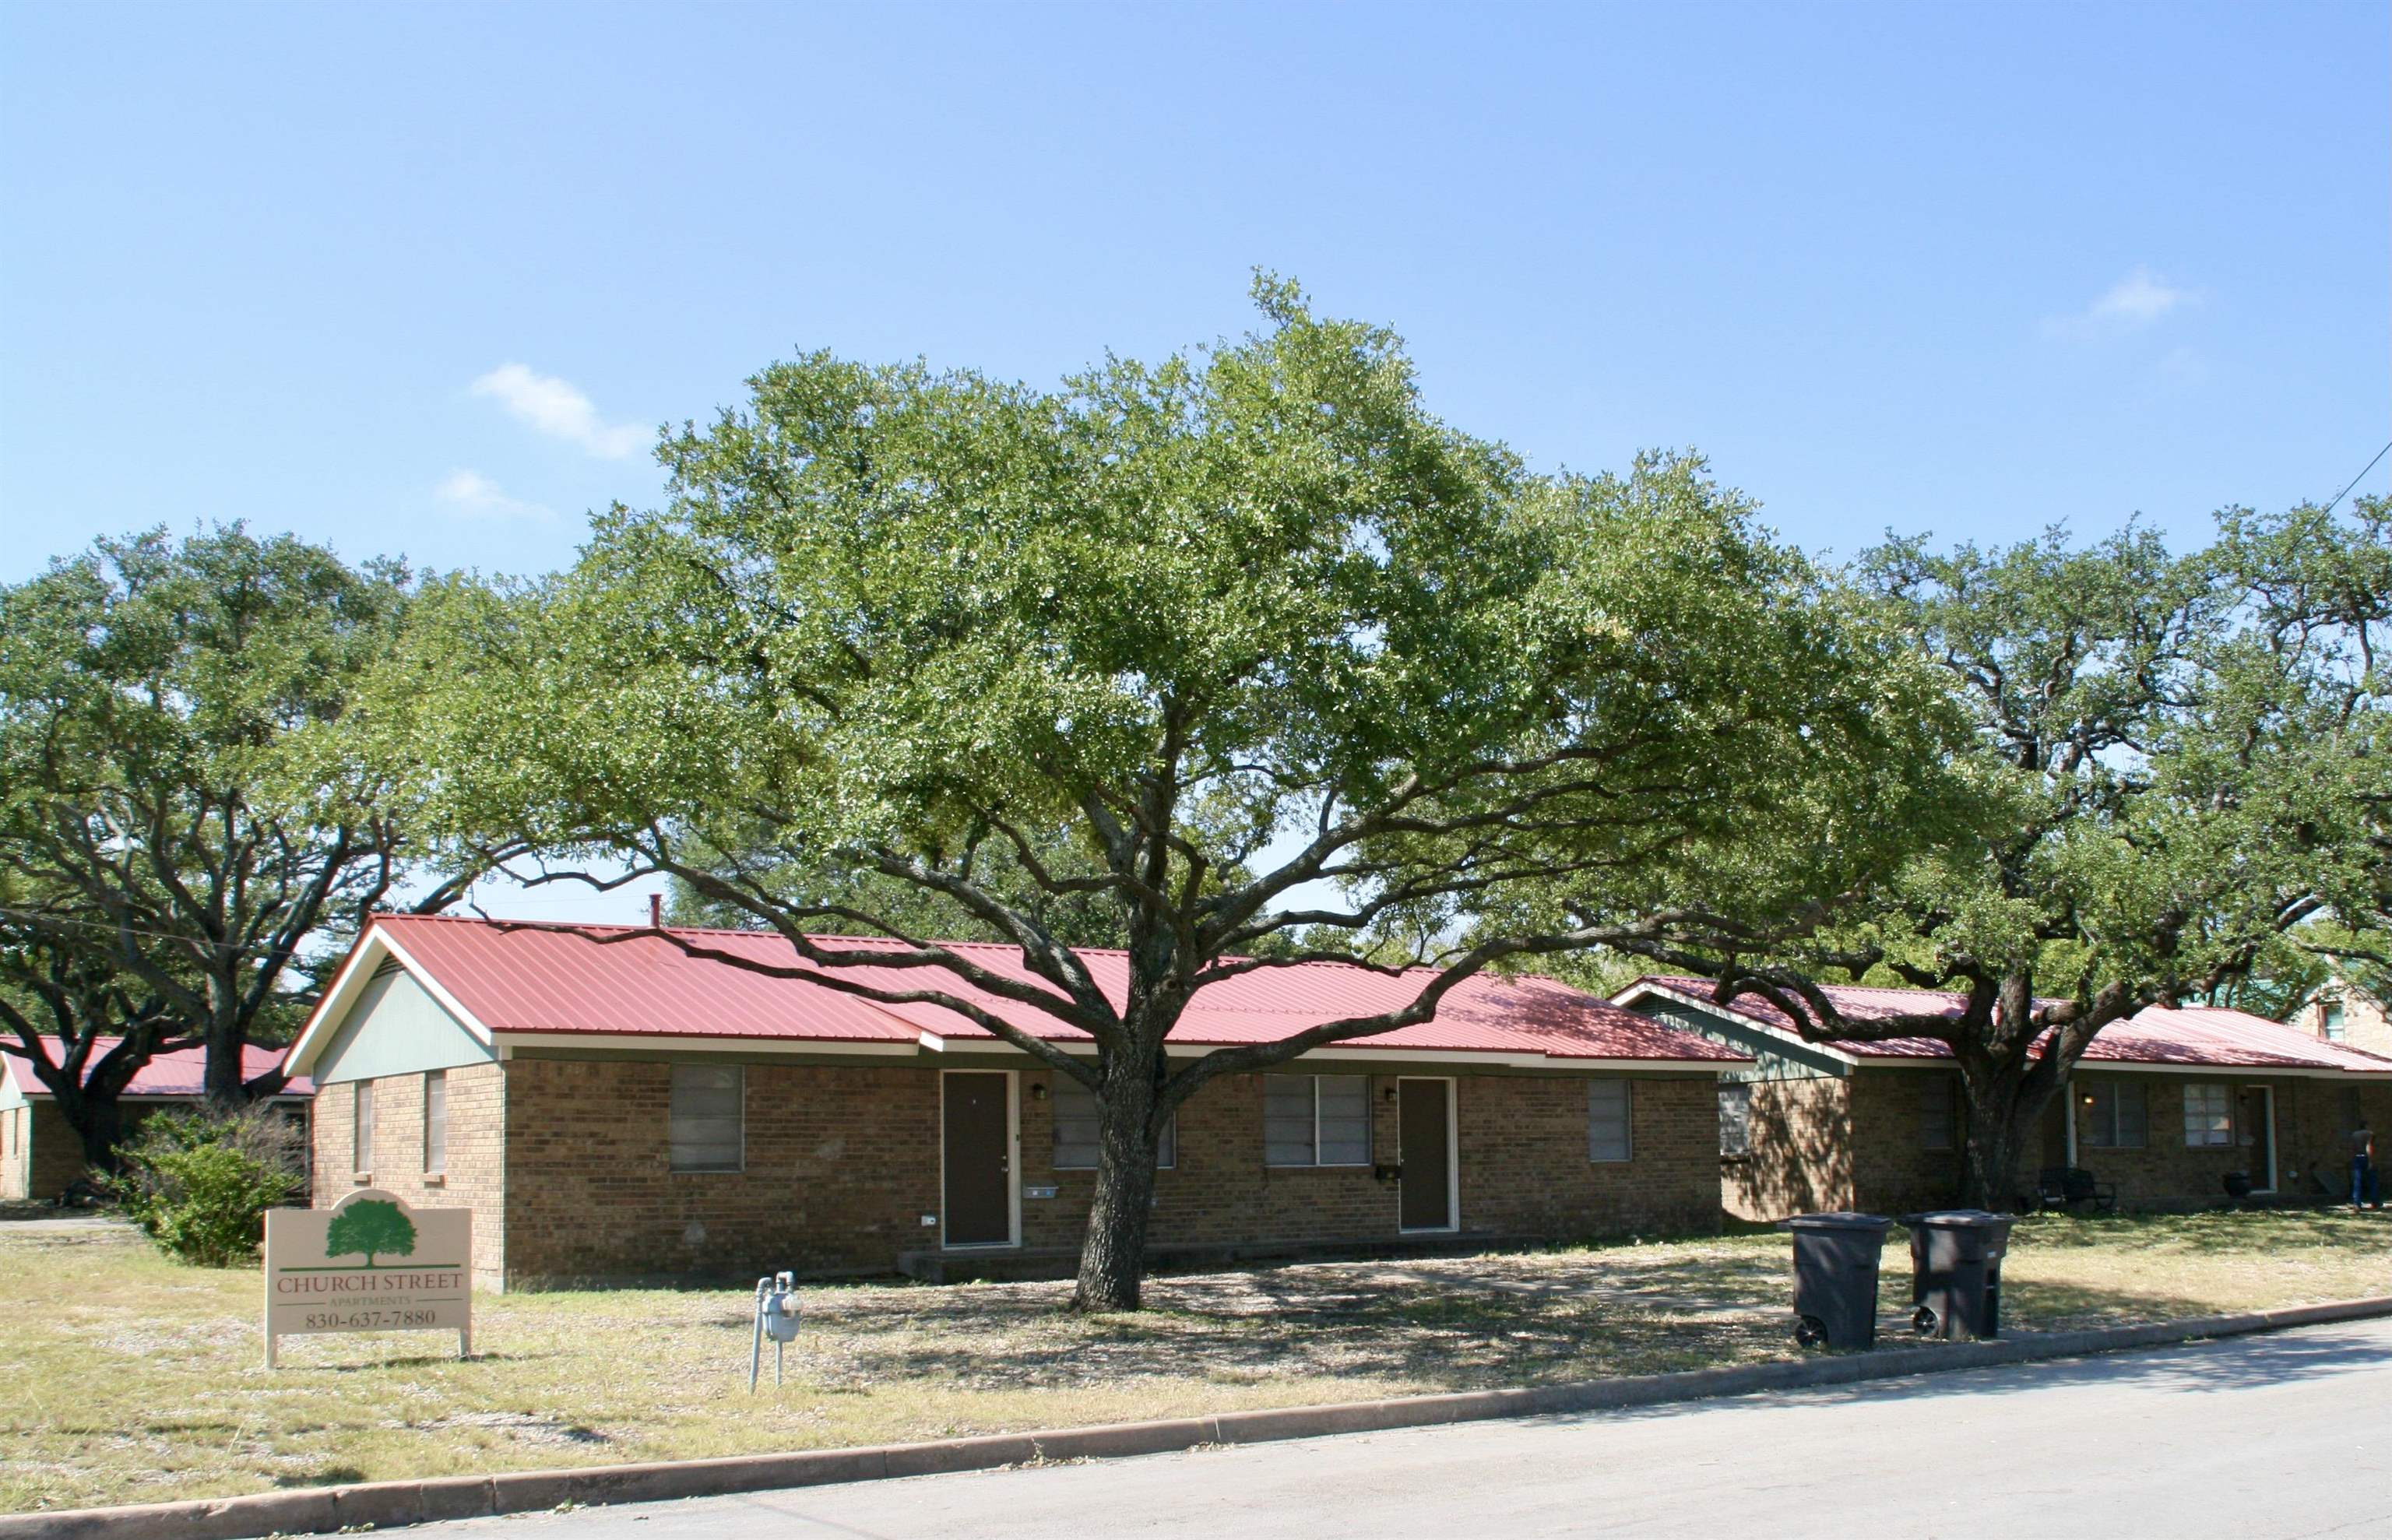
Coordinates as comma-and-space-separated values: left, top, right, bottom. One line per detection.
110, 1112, 306, 1268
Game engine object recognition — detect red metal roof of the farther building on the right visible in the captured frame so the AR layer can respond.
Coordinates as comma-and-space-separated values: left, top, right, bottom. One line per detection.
1629, 973, 2392, 1074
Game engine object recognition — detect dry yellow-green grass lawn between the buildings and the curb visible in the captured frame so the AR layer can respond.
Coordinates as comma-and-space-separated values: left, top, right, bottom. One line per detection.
0, 1210, 2392, 1511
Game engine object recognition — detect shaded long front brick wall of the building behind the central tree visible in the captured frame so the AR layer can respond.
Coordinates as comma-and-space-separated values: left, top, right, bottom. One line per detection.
505, 1060, 1718, 1284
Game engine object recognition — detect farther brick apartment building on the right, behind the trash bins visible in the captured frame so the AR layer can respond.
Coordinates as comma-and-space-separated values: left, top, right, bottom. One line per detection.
1613, 976, 2392, 1219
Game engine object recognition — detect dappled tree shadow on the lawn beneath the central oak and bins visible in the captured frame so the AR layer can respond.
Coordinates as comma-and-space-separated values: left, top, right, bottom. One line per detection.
779, 1239, 2277, 1394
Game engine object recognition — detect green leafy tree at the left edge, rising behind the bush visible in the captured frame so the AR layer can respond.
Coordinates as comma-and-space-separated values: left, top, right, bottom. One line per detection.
0, 524, 505, 1162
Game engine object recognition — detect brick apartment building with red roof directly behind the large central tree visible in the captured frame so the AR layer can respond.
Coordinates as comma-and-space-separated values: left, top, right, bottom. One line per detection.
290, 916, 1751, 1289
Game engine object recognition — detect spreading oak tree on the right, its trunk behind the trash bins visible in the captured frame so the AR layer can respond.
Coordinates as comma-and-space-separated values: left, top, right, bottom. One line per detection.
1631, 507, 2387, 1203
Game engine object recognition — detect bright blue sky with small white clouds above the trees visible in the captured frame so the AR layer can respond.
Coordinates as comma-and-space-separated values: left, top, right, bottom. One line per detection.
0, 2, 2392, 904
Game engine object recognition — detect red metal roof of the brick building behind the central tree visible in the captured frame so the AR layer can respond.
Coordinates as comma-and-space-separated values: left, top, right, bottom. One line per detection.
358, 916, 1747, 1064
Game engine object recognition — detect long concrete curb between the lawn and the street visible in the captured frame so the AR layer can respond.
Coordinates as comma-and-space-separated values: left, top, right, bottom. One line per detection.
0, 1296, 2392, 1540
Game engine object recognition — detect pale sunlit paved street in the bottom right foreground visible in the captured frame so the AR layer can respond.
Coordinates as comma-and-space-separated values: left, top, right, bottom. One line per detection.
402, 1320, 2392, 1540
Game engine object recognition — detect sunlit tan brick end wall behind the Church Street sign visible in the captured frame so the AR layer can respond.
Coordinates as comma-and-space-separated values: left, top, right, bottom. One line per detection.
311, 1064, 507, 1289
